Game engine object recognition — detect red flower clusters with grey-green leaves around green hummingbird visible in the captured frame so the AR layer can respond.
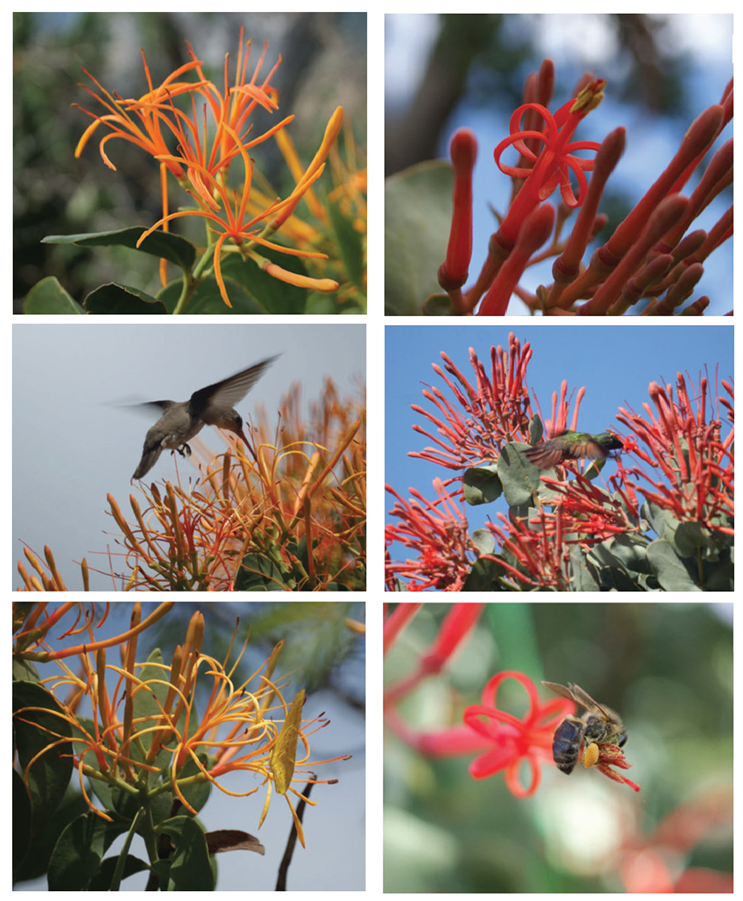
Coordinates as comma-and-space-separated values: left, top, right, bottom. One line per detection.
385, 335, 735, 591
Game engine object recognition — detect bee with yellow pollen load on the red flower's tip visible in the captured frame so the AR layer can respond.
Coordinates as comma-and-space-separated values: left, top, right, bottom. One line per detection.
542, 682, 627, 775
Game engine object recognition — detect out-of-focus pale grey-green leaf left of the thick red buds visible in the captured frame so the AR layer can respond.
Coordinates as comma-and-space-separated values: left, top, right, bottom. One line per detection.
384, 160, 454, 316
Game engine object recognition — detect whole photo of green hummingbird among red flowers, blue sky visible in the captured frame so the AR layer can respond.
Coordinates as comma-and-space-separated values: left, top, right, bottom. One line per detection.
385, 323, 734, 592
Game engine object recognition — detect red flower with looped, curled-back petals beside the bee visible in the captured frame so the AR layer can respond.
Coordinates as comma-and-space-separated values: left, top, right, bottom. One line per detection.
464, 671, 575, 798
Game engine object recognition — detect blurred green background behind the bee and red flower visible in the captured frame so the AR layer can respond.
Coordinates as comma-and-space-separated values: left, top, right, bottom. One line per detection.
384, 603, 733, 893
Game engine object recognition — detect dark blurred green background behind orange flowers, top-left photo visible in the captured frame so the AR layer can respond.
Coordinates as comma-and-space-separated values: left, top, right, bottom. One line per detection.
13, 12, 366, 312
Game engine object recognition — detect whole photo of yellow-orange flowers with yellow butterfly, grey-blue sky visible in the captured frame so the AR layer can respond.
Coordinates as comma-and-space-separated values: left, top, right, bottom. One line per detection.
13, 600, 366, 892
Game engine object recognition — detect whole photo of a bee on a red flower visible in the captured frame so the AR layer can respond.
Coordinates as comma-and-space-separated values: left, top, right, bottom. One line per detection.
384, 599, 734, 895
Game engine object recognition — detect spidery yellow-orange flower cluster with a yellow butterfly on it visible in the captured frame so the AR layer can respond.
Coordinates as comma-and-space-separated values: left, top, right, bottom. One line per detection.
14, 601, 347, 844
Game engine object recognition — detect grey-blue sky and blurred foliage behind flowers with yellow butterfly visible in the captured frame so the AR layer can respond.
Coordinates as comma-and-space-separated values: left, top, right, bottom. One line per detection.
15, 601, 366, 891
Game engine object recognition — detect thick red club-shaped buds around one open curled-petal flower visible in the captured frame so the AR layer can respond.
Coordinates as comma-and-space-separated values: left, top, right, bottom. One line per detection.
439, 60, 733, 316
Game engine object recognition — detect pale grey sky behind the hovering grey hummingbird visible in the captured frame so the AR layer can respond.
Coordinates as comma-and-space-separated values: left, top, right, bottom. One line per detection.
13, 317, 365, 590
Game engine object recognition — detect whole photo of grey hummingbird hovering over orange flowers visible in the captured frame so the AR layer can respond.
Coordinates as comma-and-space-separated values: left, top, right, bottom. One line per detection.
13, 322, 366, 591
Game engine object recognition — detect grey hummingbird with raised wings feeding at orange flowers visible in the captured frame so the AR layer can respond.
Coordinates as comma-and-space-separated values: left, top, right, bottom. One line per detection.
132, 357, 276, 479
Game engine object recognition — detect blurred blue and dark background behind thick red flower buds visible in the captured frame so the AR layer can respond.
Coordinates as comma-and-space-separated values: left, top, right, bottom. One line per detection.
385, 13, 733, 314
